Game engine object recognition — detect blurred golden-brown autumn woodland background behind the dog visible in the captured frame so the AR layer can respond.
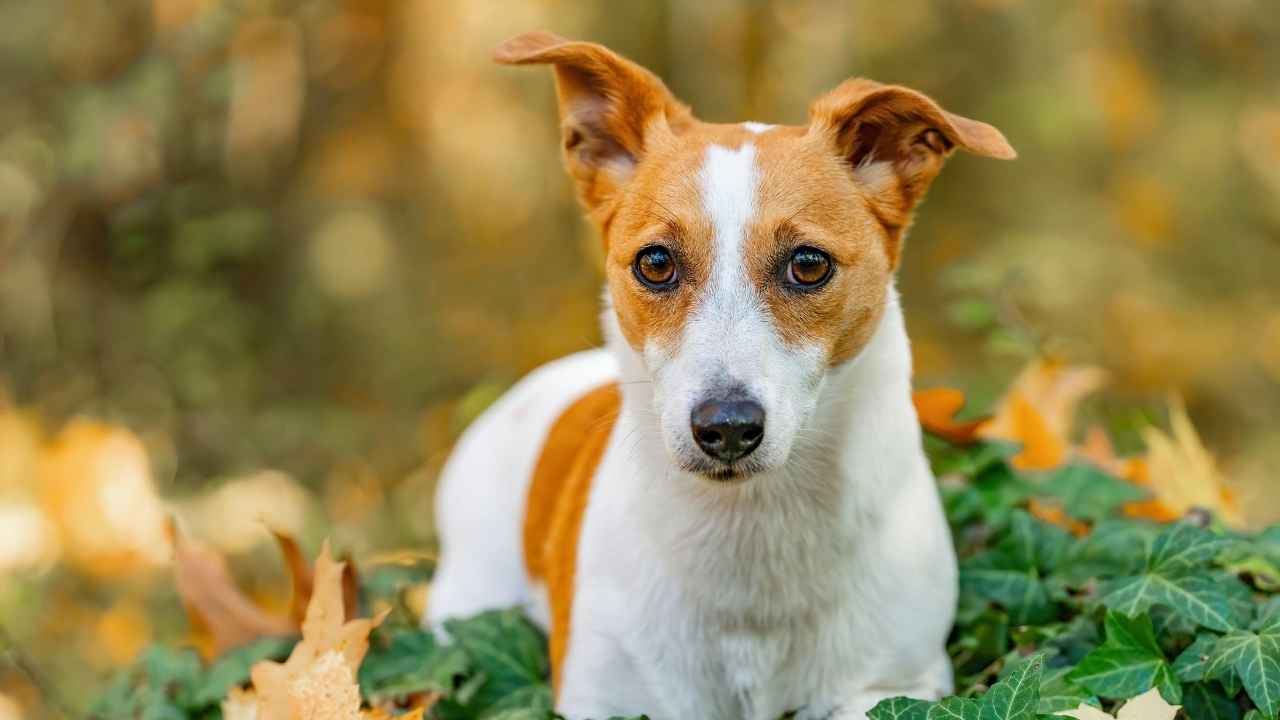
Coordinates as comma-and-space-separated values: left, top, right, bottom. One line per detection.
0, 0, 1280, 717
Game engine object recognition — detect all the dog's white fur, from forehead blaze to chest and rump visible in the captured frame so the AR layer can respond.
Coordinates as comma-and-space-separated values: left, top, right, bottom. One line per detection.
428, 145, 956, 720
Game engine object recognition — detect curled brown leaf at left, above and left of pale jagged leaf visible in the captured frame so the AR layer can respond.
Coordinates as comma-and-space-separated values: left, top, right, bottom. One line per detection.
168, 521, 297, 656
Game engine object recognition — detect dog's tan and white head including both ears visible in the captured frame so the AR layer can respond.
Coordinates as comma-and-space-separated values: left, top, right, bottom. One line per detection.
495, 32, 1015, 479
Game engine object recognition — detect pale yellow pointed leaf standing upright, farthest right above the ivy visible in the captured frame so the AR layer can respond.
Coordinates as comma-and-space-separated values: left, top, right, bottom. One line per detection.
1126, 396, 1244, 528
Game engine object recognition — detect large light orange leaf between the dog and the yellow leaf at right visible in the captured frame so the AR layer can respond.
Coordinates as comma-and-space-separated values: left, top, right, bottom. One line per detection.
978, 359, 1106, 470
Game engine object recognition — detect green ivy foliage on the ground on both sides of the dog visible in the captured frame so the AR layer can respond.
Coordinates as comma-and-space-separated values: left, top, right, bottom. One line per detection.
87, 443, 1280, 720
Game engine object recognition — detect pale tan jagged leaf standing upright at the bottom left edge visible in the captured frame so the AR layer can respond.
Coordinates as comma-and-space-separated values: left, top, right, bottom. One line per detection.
241, 542, 396, 720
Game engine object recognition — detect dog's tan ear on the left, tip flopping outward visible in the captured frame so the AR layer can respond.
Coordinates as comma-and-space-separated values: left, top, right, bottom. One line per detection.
493, 32, 692, 220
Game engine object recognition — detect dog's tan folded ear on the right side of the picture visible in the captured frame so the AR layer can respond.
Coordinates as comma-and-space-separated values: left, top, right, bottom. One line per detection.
809, 78, 1018, 266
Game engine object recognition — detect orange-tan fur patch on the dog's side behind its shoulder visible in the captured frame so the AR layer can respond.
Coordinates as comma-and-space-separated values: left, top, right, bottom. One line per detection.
524, 383, 622, 691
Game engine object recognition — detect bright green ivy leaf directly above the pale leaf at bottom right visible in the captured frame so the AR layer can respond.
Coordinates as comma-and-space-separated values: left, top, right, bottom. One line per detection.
1068, 612, 1181, 705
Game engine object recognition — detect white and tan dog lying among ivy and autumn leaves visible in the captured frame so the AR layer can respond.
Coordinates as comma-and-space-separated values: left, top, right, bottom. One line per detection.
424, 32, 1015, 720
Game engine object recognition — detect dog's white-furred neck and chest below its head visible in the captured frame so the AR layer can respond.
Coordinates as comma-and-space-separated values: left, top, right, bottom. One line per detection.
559, 291, 956, 720
